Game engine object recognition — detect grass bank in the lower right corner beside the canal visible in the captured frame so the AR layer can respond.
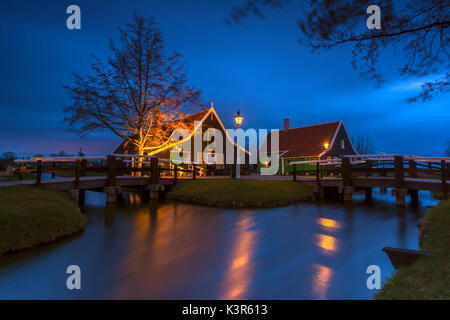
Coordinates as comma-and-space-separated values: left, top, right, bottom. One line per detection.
375, 200, 450, 299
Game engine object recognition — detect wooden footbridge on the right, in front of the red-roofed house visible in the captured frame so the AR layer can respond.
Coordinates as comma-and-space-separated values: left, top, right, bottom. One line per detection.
291, 155, 450, 207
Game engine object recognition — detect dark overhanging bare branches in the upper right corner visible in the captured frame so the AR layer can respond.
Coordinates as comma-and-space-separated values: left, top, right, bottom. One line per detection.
230, 0, 450, 102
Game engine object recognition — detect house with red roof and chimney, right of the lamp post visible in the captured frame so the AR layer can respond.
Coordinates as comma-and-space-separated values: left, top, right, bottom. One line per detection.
260, 119, 358, 174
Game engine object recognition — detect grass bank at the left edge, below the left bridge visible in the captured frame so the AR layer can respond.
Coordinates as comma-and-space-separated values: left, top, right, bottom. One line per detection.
0, 186, 86, 256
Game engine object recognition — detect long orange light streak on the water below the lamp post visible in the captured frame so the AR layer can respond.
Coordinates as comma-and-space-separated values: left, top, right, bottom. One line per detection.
221, 213, 257, 300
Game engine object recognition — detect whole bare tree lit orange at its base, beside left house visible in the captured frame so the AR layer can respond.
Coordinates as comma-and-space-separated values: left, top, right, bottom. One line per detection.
64, 14, 200, 155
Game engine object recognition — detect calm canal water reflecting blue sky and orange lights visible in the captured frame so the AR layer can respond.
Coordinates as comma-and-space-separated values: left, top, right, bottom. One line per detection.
0, 190, 436, 299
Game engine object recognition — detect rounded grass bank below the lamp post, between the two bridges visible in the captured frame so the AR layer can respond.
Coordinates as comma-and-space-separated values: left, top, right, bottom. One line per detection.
168, 179, 313, 208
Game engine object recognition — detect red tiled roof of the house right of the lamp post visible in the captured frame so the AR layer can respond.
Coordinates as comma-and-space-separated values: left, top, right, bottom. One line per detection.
266, 121, 340, 157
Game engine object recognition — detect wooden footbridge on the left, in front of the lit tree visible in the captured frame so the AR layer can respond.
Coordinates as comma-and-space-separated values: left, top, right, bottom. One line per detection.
6, 154, 203, 206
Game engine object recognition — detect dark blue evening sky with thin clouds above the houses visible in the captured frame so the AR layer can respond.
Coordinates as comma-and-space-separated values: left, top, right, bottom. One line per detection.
0, 0, 450, 156
